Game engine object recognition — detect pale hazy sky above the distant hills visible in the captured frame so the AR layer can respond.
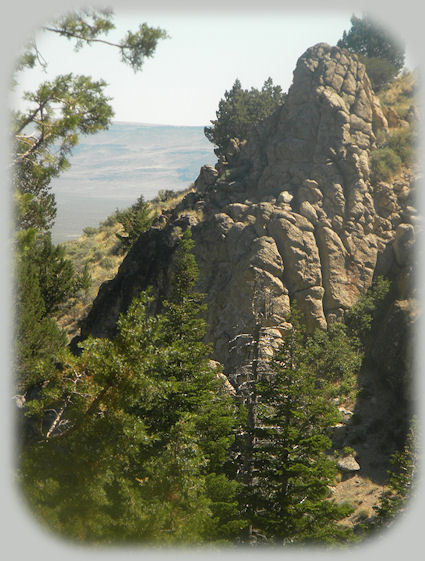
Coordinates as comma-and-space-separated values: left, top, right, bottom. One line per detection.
9, 10, 362, 125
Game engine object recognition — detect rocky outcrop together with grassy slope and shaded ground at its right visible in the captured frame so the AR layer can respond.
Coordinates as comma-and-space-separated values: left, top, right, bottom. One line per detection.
68, 44, 420, 521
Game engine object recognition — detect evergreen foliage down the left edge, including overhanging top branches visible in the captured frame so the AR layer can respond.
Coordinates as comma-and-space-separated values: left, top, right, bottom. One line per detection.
11, 9, 166, 412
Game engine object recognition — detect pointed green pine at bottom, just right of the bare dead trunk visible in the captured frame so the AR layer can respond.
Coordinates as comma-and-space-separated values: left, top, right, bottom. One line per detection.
241, 308, 352, 544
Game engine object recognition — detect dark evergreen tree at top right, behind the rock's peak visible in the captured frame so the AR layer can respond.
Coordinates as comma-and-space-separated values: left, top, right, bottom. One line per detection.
337, 15, 404, 91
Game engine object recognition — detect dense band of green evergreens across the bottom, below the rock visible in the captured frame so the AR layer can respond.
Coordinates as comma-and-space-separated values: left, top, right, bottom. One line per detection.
16, 244, 406, 545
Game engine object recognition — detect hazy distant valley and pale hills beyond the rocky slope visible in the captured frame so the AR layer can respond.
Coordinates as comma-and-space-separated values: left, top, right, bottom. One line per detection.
52, 122, 216, 243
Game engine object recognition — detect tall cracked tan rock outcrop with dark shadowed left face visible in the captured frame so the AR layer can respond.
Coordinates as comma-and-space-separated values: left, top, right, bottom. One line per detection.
82, 44, 412, 386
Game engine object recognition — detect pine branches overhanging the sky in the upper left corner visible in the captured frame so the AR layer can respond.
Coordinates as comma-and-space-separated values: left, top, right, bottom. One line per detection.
11, 9, 167, 231
